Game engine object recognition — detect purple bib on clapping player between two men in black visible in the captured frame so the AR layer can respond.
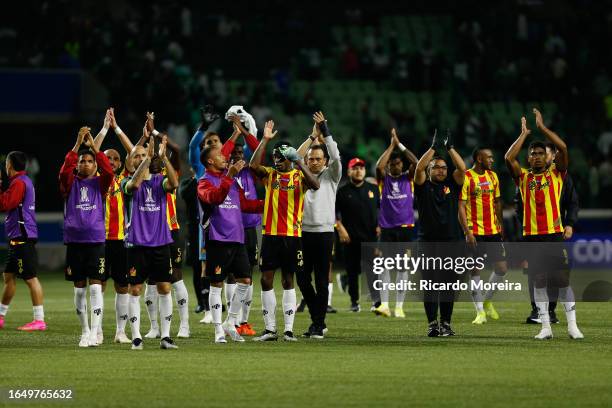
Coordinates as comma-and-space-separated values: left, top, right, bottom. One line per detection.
378, 173, 414, 228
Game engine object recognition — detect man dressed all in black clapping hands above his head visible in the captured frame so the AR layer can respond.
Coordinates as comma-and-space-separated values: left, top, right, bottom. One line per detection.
414, 131, 466, 337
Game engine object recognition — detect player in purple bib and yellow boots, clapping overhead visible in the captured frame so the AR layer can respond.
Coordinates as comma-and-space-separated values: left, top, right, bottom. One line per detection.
374, 129, 417, 318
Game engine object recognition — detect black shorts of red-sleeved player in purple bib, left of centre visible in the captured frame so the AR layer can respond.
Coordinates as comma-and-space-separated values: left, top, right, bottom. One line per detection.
205, 241, 251, 282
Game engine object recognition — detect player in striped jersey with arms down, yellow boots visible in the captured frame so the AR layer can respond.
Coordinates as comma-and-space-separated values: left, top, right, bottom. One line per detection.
459, 147, 508, 324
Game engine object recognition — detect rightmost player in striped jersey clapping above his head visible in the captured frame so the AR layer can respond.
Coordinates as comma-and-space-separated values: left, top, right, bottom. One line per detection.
505, 108, 584, 340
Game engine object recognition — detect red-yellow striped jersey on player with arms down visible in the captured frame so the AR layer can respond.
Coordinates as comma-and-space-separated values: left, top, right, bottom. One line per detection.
459, 169, 502, 235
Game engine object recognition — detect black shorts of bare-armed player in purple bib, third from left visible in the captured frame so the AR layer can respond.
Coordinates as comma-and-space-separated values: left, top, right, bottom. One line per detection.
127, 245, 172, 285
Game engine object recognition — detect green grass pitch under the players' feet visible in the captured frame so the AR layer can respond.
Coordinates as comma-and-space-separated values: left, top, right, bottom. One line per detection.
0, 274, 612, 407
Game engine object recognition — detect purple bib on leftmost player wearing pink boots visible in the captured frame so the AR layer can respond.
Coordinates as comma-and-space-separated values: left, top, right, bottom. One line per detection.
4, 174, 38, 239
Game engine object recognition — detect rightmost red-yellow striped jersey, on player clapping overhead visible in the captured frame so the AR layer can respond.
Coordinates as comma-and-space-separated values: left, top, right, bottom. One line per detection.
516, 163, 566, 235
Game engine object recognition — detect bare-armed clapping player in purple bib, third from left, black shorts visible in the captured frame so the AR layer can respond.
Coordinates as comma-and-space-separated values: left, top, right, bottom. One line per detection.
121, 137, 178, 350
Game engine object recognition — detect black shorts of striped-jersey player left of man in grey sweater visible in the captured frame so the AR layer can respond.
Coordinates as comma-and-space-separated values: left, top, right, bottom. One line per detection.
260, 235, 304, 273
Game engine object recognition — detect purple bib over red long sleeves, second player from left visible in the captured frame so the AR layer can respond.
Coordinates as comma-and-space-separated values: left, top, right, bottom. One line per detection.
64, 177, 106, 244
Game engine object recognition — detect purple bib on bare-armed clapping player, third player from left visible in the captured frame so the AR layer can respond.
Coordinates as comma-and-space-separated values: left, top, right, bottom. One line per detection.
125, 174, 172, 247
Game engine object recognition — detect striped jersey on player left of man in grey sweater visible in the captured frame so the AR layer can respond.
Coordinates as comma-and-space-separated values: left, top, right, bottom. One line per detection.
263, 167, 306, 237
